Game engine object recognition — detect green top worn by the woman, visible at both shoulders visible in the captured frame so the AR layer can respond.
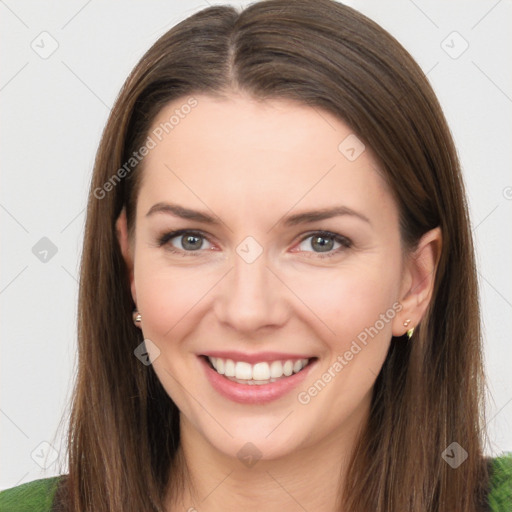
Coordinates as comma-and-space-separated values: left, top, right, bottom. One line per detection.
0, 452, 512, 512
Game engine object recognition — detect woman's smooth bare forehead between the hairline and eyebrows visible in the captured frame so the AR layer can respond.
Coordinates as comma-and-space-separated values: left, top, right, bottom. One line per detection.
136, 95, 396, 228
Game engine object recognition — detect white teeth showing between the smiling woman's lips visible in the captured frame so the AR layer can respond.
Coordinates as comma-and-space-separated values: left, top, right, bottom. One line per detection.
202, 356, 317, 386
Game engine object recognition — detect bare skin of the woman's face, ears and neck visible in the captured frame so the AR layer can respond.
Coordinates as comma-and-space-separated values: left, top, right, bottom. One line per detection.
117, 93, 441, 512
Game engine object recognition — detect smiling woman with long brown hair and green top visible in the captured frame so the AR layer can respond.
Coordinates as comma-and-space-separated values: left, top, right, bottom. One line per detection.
0, 0, 512, 512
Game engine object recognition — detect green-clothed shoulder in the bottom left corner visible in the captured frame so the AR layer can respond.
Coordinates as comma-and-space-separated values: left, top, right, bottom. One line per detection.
0, 476, 62, 512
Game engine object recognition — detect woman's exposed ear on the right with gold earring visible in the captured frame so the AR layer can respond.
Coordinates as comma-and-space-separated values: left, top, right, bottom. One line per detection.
393, 227, 442, 336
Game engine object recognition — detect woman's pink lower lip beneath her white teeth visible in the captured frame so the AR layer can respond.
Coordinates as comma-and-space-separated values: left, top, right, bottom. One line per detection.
199, 356, 316, 404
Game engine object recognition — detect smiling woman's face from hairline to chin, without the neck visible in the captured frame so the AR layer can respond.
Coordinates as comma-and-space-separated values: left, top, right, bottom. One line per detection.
120, 95, 416, 459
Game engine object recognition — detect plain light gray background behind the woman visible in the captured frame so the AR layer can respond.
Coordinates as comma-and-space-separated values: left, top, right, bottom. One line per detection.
0, 0, 512, 489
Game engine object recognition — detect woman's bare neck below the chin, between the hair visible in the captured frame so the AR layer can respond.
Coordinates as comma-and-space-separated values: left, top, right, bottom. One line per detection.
166, 403, 369, 512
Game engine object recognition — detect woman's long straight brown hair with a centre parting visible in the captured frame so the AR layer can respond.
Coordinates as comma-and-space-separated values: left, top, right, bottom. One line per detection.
54, 0, 487, 512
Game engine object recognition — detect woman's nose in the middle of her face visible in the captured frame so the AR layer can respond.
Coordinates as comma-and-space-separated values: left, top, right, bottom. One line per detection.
214, 247, 289, 337
